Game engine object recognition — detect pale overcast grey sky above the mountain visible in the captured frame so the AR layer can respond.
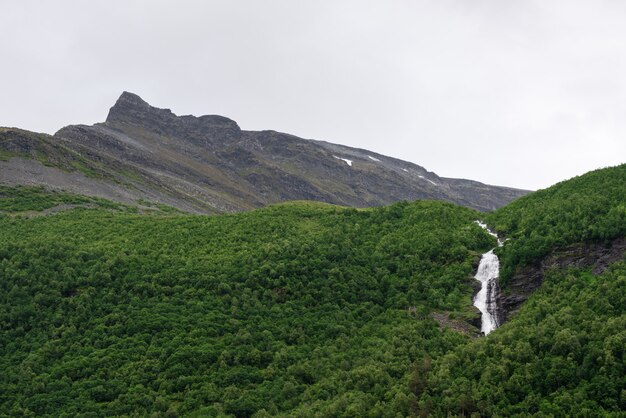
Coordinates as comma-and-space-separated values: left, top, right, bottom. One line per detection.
0, 0, 626, 189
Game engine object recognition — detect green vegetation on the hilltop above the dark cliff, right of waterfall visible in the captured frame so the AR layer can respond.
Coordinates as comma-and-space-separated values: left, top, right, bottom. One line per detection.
488, 164, 626, 285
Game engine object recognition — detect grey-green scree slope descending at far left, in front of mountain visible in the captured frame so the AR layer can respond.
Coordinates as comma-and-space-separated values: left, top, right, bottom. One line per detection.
0, 128, 218, 213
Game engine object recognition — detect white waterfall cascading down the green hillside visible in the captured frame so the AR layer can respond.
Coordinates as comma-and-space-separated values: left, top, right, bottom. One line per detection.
474, 221, 502, 335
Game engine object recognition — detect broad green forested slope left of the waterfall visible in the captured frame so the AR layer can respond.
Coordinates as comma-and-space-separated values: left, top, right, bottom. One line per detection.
0, 191, 494, 416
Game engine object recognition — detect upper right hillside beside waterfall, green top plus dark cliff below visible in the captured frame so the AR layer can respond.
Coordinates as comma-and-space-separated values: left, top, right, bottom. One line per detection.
487, 164, 626, 319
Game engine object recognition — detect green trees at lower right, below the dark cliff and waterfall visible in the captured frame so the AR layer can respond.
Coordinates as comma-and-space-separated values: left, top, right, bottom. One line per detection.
417, 263, 626, 416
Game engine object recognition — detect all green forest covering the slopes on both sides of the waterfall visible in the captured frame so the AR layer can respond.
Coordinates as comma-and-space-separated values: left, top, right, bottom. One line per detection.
0, 165, 626, 418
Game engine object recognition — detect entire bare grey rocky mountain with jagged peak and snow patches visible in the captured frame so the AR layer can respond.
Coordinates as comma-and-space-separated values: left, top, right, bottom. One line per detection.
0, 92, 528, 213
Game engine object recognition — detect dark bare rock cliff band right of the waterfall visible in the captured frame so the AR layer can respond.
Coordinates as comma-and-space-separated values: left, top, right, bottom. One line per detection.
498, 237, 626, 321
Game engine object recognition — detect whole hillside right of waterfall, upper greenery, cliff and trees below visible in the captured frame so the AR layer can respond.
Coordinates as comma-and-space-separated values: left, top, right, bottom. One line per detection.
414, 165, 626, 416
